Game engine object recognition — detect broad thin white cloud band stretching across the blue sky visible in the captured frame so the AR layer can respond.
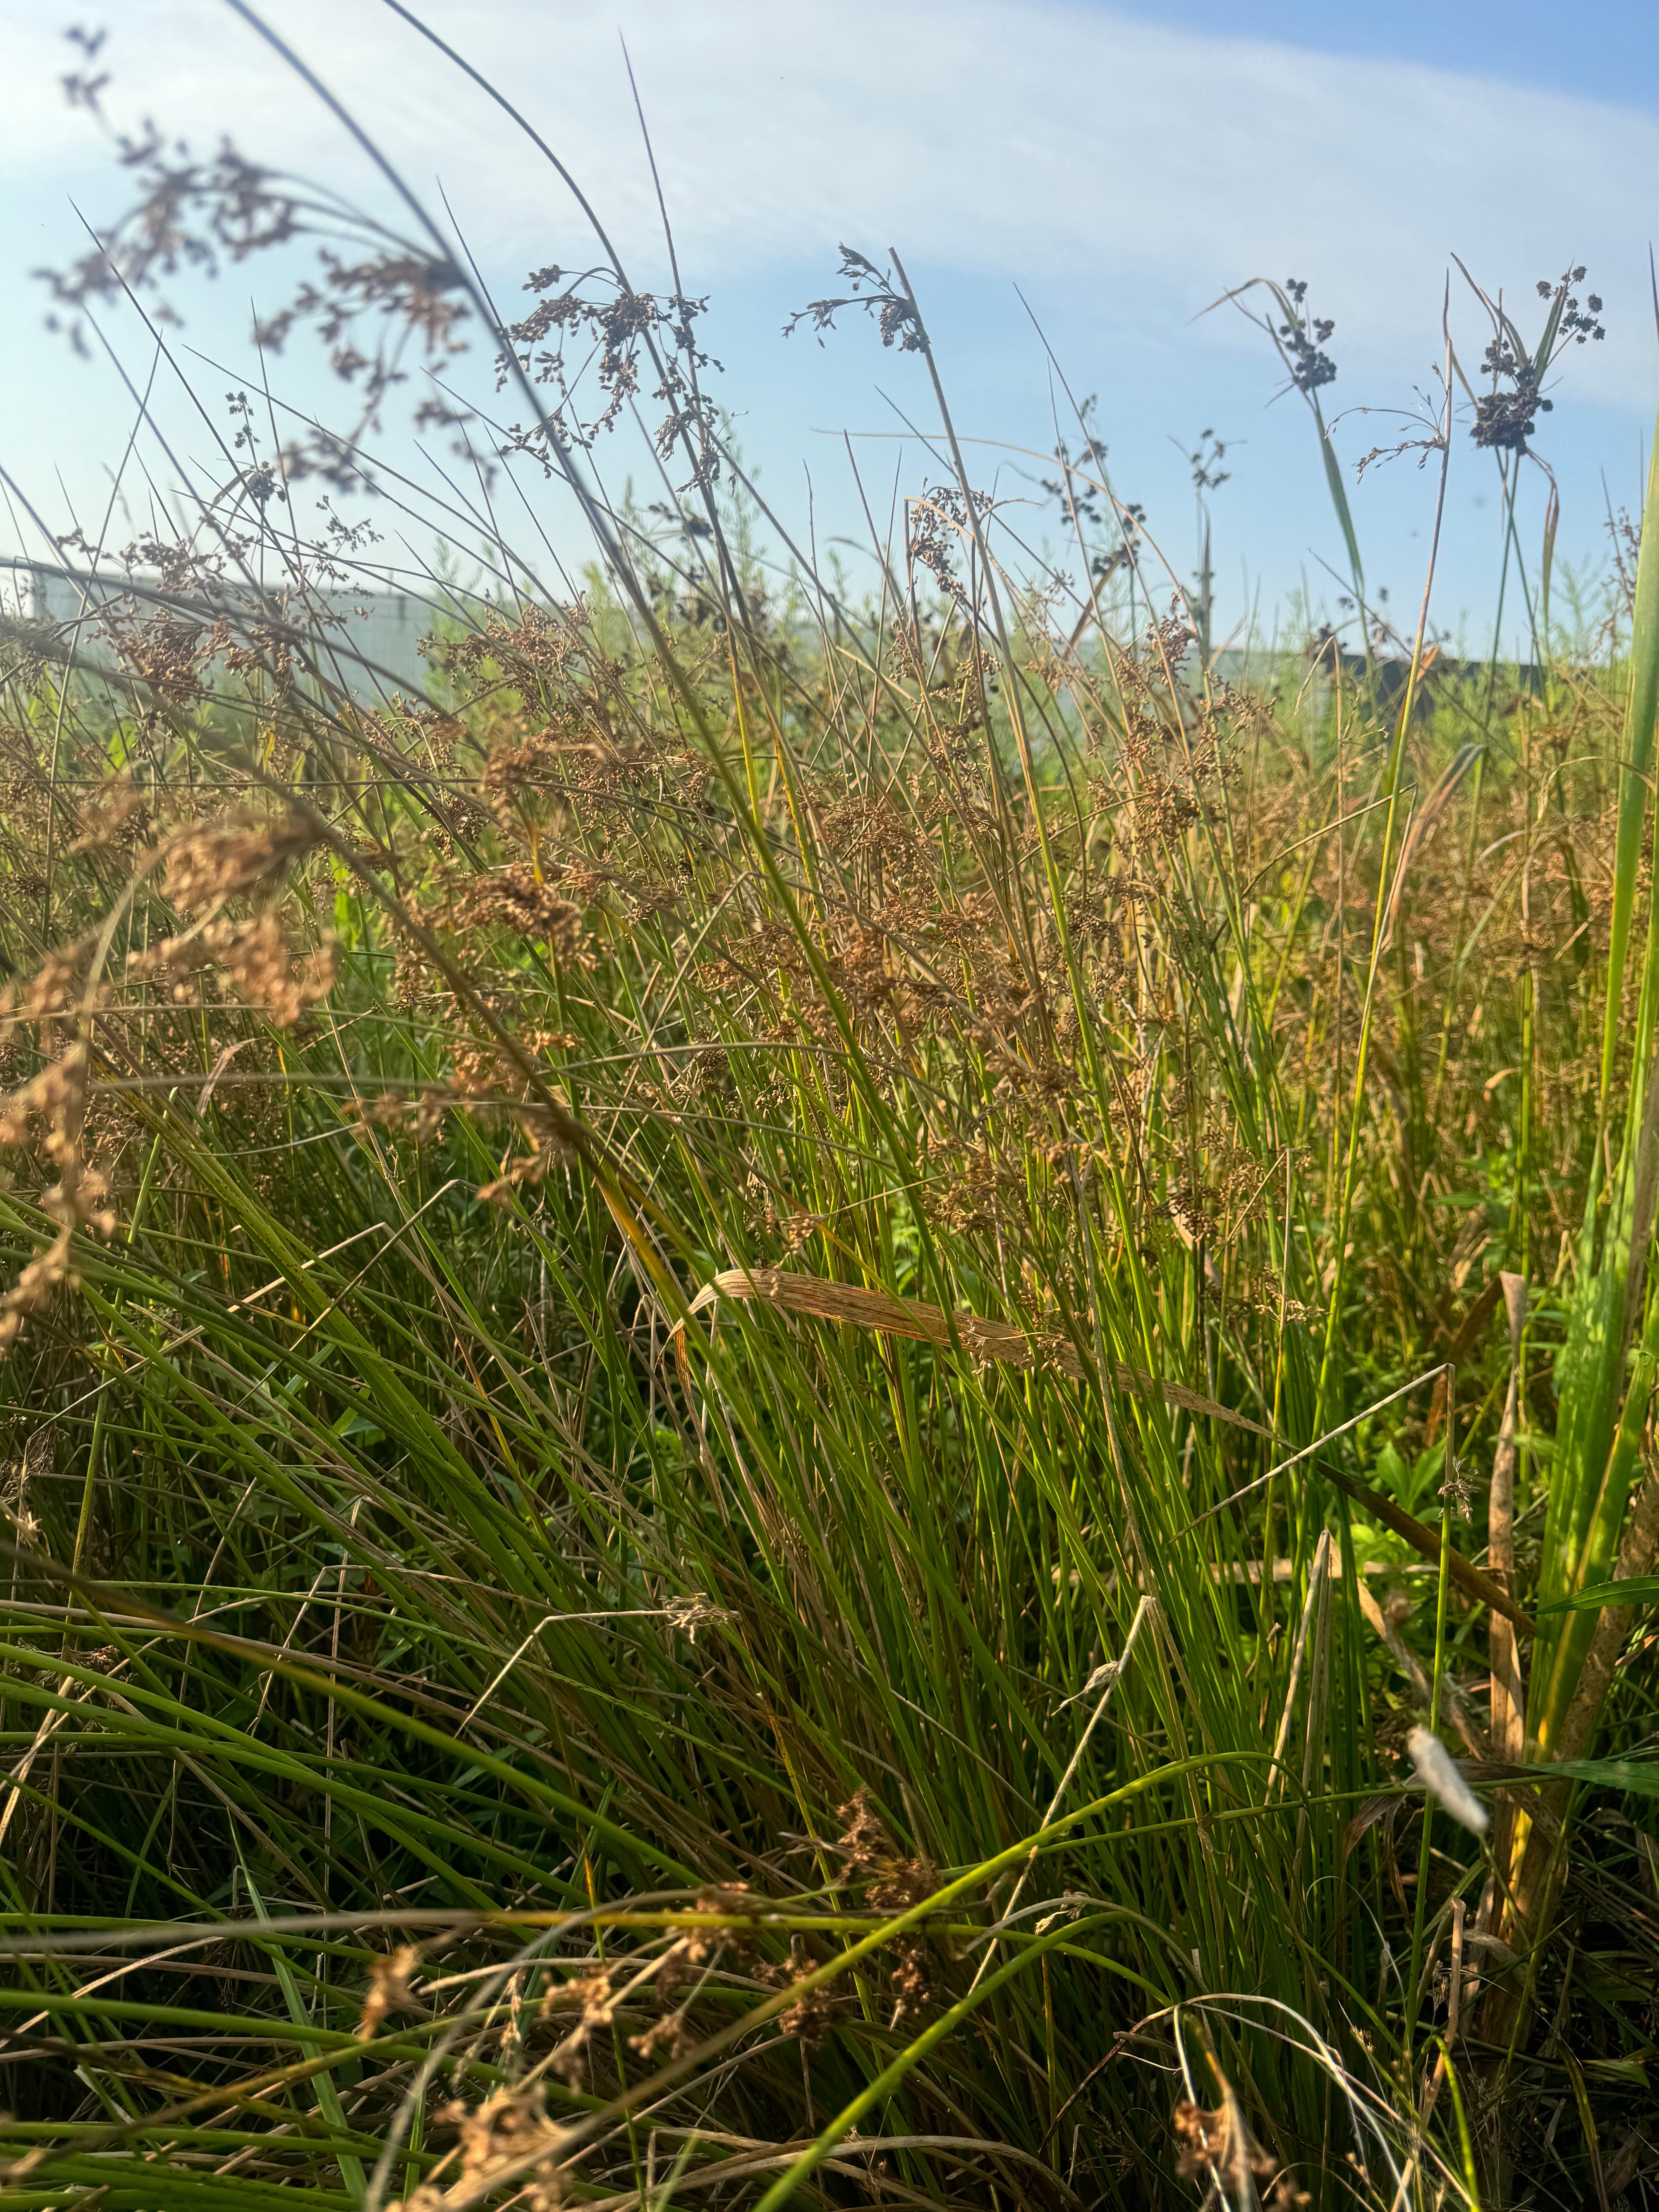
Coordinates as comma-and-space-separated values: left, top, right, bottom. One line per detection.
0, 0, 1659, 403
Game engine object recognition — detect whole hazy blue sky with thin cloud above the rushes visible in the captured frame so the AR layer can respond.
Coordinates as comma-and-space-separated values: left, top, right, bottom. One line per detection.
0, 0, 1659, 646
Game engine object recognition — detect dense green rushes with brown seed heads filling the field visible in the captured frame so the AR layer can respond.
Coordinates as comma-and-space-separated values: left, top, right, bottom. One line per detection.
0, 21, 1659, 2212
